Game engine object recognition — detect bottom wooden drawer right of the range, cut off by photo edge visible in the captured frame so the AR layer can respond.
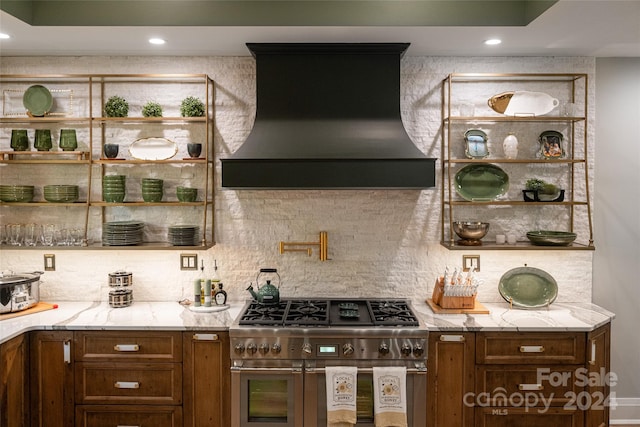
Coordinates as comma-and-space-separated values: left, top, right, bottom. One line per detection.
476, 408, 584, 427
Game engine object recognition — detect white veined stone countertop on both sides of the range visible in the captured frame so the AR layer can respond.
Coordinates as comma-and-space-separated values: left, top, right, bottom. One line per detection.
0, 301, 615, 343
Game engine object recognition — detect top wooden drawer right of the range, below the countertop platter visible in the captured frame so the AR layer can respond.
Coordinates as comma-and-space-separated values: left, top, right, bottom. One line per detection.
476, 332, 585, 365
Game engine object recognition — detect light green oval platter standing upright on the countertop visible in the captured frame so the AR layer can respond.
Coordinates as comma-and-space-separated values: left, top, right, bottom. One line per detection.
498, 267, 558, 308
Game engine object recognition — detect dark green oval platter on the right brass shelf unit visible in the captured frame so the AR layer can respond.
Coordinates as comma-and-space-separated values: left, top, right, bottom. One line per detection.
455, 163, 509, 201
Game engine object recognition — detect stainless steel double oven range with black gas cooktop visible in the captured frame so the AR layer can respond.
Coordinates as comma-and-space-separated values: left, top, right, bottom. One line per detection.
229, 299, 427, 427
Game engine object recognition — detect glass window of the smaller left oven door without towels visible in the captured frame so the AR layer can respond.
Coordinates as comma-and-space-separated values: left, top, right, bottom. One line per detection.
248, 379, 289, 423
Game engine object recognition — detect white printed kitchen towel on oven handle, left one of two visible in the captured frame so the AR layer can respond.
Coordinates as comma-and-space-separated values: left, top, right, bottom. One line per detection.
325, 366, 358, 427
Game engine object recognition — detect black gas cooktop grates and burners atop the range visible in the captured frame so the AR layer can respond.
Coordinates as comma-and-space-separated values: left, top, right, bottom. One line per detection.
239, 299, 418, 327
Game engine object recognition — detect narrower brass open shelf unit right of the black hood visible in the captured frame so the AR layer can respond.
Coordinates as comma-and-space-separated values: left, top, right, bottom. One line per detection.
440, 73, 594, 251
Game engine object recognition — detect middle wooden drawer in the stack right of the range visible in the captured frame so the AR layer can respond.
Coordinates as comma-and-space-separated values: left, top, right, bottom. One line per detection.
476, 365, 582, 406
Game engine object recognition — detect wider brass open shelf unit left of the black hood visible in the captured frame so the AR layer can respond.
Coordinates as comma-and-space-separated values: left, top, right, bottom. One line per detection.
0, 74, 215, 250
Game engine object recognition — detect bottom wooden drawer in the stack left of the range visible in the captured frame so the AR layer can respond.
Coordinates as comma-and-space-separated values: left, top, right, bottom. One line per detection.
76, 405, 182, 427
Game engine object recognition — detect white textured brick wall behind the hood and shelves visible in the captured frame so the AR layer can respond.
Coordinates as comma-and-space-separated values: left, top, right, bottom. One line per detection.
0, 57, 597, 301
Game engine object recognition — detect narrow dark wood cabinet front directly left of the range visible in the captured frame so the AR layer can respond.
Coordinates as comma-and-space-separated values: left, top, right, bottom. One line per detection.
183, 331, 231, 427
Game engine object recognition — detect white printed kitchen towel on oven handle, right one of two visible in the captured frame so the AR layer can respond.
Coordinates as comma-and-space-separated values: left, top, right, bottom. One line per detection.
373, 366, 407, 427
